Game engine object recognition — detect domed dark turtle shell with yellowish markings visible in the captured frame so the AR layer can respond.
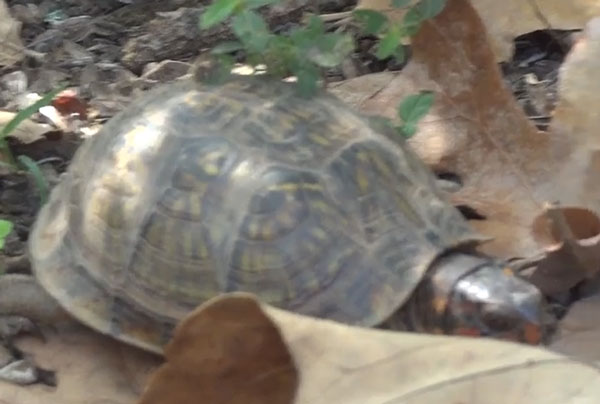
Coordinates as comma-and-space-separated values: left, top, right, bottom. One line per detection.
30, 78, 486, 352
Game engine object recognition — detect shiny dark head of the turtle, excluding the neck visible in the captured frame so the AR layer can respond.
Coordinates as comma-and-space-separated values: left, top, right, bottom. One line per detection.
445, 263, 547, 345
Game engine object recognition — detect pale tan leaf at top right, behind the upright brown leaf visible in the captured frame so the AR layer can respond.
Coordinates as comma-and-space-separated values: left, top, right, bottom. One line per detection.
356, 0, 600, 61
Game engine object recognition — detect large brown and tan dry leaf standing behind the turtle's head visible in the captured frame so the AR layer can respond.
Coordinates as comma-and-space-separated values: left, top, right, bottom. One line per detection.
331, 0, 600, 257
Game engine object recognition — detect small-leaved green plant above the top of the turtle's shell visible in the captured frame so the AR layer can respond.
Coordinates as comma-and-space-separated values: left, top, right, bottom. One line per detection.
200, 0, 446, 137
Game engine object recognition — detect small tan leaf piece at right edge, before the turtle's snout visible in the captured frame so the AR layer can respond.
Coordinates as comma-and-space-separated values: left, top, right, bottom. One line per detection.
550, 295, 600, 366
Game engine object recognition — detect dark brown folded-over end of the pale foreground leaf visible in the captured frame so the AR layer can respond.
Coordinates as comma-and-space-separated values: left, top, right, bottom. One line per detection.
139, 298, 299, 404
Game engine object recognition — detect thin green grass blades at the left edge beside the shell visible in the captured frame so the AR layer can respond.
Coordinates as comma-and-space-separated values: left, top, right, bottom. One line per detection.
0, 85, 66, 204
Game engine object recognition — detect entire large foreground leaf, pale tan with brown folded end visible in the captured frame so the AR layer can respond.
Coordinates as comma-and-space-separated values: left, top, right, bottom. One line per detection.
138, 293, 600, 404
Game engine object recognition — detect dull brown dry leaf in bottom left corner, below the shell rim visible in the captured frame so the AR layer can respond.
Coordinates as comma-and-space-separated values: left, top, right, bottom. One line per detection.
0, 326, 161, 404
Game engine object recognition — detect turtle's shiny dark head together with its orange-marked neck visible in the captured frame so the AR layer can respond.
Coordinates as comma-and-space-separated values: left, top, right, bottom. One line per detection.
410, 253, 552, 345
